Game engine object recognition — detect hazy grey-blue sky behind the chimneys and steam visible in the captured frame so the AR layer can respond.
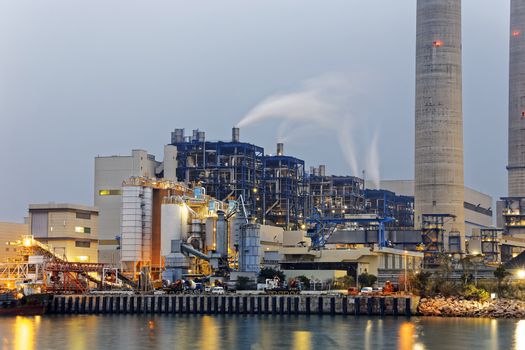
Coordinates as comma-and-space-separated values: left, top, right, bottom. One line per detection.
0, 0, 510, 222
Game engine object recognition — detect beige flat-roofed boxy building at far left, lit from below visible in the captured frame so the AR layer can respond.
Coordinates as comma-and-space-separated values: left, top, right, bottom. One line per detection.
29, 203, 99, 263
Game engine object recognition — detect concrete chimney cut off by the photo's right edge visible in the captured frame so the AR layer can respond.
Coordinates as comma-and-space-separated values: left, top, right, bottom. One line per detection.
507, 0, 525, 197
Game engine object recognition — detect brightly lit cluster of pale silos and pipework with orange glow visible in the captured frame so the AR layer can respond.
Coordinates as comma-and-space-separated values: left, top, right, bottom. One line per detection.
120, 177, 239, 281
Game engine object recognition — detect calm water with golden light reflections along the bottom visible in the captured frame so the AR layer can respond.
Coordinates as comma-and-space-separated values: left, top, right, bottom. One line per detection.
0, 315, 525, 350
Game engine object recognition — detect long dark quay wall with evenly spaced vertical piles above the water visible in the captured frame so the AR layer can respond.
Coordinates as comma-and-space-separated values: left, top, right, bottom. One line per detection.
47, 294, 419, 316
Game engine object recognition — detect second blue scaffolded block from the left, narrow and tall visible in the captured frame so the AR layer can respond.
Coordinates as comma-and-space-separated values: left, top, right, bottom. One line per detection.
264, 155, 306, 229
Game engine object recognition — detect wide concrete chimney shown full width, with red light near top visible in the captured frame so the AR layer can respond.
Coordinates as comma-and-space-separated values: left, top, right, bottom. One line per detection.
415, 0, 465, 251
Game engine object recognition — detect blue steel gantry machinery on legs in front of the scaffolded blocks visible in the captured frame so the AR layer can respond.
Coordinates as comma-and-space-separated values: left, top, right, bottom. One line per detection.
306, 210, 395, 250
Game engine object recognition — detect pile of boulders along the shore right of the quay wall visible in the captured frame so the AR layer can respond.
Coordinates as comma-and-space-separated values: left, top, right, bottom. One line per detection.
418, 297, 525, 319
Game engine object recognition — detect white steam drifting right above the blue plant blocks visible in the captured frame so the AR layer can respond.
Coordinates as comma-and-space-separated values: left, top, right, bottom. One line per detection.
237, 74, 380, 183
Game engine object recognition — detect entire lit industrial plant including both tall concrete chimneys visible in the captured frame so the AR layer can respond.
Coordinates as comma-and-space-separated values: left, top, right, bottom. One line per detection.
0, 0, 525, 311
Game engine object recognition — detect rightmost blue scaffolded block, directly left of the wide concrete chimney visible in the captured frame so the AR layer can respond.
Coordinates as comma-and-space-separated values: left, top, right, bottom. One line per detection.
365, 189, 414, 228
